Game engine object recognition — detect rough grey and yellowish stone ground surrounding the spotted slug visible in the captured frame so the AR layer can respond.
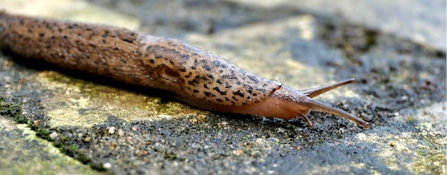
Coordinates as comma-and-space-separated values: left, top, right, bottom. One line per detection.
0, 0, 447, 174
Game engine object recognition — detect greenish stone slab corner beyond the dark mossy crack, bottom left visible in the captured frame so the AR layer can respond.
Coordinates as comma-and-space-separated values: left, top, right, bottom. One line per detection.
0, 115, 95, 174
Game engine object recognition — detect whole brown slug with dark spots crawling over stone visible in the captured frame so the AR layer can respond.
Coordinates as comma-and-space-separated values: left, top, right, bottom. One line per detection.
0, 11, 368, 128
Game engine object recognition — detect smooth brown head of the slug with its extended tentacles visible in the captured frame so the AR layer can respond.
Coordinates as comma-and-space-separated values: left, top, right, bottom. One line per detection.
229, 79, 368, 128
